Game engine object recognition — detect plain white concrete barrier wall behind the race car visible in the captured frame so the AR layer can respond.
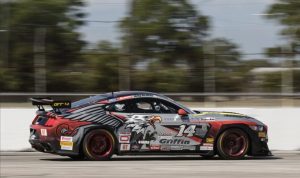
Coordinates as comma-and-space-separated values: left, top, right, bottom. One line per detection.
0, 108, 300, 151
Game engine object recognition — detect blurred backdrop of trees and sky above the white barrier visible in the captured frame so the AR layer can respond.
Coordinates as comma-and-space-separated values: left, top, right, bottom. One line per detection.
0, 0, 300, 107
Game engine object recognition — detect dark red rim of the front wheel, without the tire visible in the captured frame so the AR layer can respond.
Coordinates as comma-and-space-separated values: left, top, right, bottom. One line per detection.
222, 132, 248, 157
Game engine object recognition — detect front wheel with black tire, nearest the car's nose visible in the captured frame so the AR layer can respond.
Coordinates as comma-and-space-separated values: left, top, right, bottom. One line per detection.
217, 128, 249, 159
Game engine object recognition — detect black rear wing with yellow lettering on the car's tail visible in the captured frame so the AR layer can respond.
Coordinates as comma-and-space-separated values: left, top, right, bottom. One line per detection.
30, 98, 71, 112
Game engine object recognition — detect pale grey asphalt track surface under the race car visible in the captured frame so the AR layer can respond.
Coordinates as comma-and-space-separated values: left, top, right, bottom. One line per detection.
0, 151, 300, 178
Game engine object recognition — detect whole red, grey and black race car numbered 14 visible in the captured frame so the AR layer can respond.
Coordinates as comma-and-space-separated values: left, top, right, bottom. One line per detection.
29, 91, 272, 160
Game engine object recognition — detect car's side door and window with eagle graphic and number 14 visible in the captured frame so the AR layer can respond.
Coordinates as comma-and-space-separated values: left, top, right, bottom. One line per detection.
110, 98, 207, 151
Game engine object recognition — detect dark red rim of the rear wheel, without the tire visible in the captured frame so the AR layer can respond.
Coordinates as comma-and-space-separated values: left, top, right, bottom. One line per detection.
88, 132, 113, 157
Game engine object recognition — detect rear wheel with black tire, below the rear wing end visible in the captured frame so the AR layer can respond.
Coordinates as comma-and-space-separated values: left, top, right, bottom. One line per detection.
82, 129, 116, 161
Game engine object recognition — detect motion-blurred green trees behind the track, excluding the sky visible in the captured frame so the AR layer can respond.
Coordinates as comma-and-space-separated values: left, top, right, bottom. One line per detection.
0, 0, 300, 92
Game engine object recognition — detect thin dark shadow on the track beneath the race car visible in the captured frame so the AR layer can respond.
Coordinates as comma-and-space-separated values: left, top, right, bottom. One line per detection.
40, 155, 283, 162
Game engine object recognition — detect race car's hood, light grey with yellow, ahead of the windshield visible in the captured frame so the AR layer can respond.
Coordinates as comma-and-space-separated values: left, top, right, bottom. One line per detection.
192, 111, 265, 125
